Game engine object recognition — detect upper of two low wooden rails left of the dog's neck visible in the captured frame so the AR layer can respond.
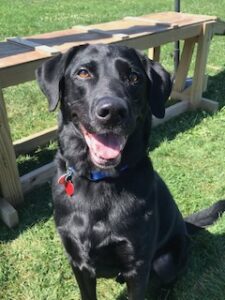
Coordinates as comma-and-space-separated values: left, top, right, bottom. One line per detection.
13, 126, 57, 155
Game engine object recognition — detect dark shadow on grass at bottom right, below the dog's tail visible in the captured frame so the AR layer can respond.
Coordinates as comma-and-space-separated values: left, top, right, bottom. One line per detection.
116, 230, 225, 300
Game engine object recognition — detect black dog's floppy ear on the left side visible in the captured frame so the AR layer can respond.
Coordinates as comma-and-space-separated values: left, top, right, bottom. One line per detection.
35, 45, 87, 111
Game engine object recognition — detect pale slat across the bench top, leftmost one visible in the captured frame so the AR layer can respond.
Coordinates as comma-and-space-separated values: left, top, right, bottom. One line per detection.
7, 37, 60, 56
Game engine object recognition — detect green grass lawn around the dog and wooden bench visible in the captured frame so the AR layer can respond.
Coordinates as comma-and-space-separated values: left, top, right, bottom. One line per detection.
0, 0, 225, 300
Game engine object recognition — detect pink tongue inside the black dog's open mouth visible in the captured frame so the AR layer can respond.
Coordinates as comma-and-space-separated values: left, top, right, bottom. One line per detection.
88, 133, 123, 159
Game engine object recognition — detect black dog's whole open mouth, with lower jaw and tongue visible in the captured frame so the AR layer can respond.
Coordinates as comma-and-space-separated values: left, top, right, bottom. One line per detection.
80, 125, 127, 168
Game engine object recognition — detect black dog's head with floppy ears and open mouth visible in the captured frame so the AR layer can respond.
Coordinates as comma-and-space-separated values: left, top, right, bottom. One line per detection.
36, 45, 171, 168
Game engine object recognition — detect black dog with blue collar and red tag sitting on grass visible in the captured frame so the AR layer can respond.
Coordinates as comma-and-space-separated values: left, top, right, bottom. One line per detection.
37, 45, 225, 300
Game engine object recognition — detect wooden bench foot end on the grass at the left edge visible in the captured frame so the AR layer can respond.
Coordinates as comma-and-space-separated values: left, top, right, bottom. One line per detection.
0, 198, 19, 228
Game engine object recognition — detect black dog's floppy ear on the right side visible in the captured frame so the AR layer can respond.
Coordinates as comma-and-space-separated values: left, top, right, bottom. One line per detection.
139, 54, 172, 119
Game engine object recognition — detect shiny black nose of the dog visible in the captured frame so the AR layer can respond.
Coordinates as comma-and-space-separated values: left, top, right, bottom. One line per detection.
95, 97, 128, 122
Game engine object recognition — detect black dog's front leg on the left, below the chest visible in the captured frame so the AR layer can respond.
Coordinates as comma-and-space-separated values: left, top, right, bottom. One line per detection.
72, 265, 97, 300
